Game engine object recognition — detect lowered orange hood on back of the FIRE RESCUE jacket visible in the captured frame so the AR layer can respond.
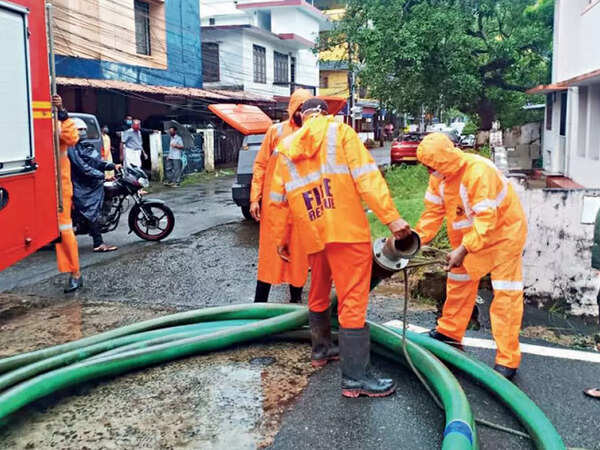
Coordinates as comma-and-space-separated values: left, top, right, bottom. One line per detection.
283, 116, 334, 161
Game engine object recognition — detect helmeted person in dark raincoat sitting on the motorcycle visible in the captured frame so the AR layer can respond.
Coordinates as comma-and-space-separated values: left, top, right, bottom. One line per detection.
67, 118, 120, 252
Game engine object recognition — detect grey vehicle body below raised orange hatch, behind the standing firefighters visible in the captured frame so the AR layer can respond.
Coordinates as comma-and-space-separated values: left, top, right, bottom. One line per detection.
231, 134, 265, 220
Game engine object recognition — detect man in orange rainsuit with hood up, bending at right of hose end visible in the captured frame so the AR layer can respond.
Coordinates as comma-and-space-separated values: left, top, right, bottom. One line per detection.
416, 133, 527, 379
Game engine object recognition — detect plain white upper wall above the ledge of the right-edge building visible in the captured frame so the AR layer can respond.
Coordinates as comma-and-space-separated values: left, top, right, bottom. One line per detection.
552, 0, 600, 82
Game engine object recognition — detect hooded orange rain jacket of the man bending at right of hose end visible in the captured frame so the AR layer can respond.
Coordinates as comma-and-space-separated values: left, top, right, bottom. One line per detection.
416, 133, 527, 279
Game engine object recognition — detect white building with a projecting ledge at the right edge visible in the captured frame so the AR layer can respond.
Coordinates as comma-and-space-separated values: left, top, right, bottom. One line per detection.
528, 0, 600, 188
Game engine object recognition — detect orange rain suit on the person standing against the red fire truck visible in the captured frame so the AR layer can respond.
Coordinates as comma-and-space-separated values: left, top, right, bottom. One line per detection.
56, 119, 79, 273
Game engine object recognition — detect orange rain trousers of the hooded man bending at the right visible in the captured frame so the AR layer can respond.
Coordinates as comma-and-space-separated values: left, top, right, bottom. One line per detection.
437, 255, 523, 369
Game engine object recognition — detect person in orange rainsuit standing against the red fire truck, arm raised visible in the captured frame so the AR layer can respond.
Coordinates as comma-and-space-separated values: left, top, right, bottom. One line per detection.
52, 95, 83, 293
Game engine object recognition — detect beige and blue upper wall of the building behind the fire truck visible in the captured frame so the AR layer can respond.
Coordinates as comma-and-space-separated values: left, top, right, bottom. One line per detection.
54, 0, 202, 87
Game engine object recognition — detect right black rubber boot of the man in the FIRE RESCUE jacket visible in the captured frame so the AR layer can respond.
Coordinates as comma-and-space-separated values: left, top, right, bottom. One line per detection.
339, 325, 396, 398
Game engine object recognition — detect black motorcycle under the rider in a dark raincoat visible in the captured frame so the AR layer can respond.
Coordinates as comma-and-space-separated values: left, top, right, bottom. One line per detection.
73, 167, 175, 241
